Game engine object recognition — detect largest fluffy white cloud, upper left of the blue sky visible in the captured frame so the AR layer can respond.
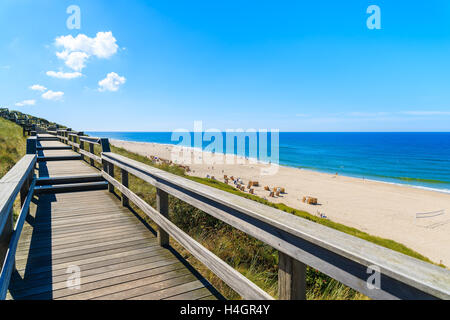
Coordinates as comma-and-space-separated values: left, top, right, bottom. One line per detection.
55, 31, 118, 71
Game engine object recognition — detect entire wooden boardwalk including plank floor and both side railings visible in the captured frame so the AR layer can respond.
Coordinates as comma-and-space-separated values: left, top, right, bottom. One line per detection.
0, 125, 450, 300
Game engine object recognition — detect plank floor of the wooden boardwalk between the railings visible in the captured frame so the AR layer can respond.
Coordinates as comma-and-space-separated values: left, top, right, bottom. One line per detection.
7, 135, 221, 300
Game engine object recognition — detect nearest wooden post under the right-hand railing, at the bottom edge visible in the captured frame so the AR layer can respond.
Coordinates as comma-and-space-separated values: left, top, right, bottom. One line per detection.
278, 251, 306, 300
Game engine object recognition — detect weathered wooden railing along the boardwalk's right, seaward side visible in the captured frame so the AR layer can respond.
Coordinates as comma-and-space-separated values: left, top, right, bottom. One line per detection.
2, 130, 450, 299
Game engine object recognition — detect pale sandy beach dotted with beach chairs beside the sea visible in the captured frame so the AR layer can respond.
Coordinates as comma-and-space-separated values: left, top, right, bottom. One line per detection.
111, 139, 450, 267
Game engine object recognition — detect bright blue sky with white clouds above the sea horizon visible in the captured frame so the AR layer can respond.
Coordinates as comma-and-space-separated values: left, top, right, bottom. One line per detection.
0, 0, 450, 131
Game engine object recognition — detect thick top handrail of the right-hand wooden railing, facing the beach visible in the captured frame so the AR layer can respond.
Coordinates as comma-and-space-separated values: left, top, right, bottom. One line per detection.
102, 152, 450, 299
